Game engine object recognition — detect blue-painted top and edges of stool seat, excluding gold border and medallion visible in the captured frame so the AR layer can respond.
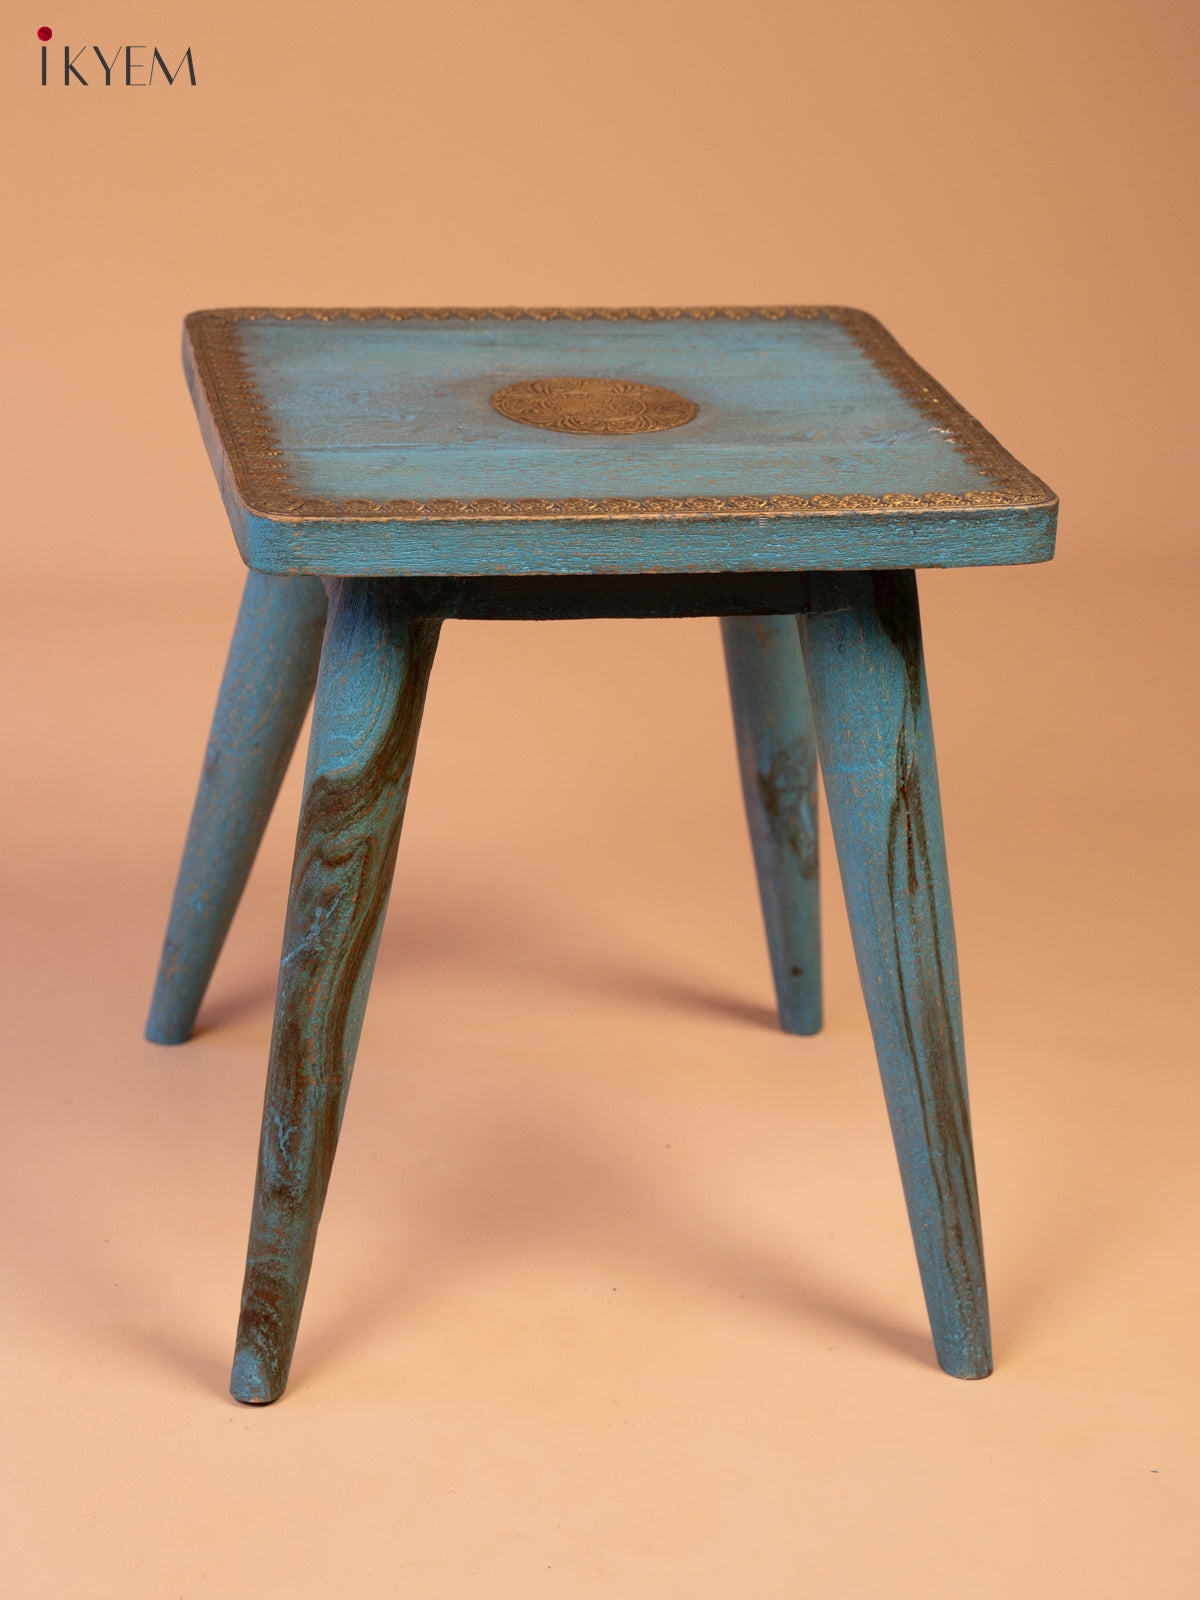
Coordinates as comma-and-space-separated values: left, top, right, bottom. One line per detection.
184, 317, 1056, 576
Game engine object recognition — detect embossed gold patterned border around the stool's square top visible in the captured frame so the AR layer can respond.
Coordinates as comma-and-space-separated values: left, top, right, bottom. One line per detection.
186, 306, 1056, 522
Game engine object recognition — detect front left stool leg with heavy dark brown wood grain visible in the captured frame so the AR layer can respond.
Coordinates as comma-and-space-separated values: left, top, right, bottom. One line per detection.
230, 578, 440, 1405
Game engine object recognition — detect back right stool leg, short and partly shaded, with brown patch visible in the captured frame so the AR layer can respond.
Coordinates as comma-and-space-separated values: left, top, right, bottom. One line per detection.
722, 616, 821, 1034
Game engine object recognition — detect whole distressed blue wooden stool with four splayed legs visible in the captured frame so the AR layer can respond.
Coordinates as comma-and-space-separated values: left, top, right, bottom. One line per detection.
147, 307, 1056, 1403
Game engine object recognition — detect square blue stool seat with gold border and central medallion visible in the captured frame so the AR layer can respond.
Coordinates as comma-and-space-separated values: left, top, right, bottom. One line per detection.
184, 306, 1058, 576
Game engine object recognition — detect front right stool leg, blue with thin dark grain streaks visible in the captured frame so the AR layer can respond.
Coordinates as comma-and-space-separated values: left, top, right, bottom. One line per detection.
798, 571, 992, 1378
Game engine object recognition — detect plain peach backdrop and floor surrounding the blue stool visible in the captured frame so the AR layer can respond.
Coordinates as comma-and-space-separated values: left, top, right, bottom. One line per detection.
0, 0, 1200, 1600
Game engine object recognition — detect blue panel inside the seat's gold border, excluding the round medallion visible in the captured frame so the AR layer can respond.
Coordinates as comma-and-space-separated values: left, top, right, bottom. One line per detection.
242, 318, 992, 499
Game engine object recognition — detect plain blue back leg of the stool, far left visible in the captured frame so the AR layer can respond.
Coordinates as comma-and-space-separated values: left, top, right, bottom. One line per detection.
146, 573, 325, 1045
